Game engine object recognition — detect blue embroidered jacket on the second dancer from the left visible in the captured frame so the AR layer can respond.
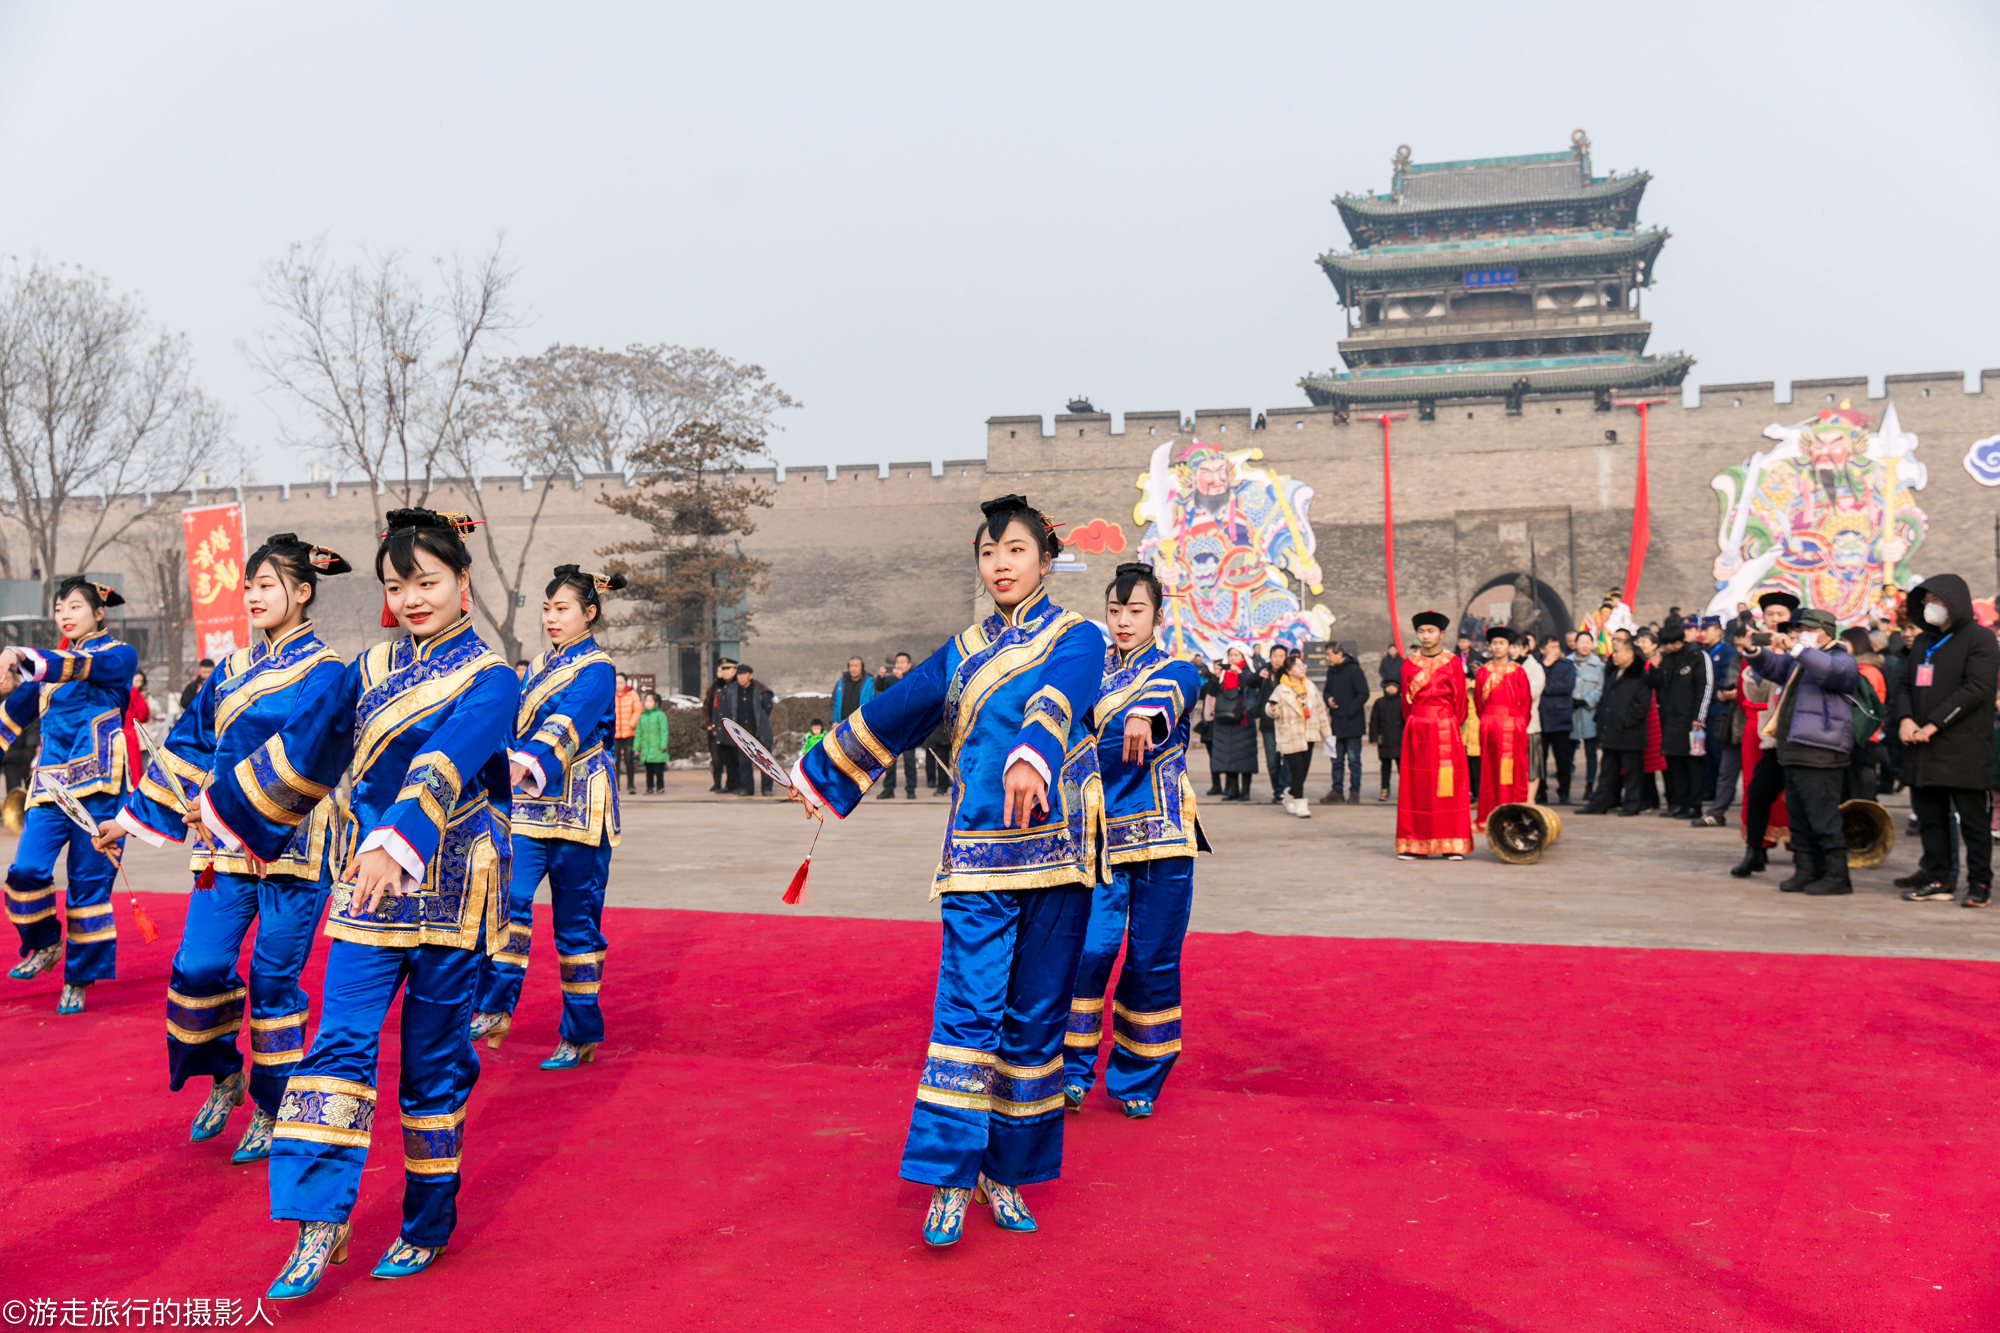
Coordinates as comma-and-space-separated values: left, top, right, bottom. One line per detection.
118, 624, 354, 885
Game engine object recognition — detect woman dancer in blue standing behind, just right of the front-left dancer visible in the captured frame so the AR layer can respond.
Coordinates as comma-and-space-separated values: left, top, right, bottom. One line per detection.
472, 564, 626, 1069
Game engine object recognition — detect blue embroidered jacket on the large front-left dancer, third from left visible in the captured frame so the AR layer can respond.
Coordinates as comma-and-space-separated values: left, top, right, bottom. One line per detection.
202, 616, 520, 951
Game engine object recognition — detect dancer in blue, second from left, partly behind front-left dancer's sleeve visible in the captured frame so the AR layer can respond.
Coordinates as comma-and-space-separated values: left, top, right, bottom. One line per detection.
96, 532, 352, 1163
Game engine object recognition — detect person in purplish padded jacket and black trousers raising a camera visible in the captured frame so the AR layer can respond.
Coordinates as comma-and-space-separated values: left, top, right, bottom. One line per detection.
1750, 608, 1862, 897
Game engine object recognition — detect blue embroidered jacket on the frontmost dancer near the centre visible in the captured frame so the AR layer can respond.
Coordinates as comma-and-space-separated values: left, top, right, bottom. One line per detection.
794, 588, 1104, 897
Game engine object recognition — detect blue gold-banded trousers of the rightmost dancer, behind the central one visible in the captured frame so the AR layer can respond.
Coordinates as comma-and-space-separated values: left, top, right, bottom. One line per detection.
1062, 857, 1194, 1101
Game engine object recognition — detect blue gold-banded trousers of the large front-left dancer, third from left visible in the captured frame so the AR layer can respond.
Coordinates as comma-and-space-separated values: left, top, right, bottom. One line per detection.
270, 939, 486, 1249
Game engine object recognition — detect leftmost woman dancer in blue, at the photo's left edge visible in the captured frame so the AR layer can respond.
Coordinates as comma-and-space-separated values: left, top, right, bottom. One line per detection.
0, 576, 138, 1013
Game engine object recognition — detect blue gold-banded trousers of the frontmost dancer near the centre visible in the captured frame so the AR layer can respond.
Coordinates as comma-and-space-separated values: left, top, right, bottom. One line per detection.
902, 885, 1090, 1187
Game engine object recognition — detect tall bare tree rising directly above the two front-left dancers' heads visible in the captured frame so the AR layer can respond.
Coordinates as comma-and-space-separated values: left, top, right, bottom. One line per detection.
248, 242, 516, 520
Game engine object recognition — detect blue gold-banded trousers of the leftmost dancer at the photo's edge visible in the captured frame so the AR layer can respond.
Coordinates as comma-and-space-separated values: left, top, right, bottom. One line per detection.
6, 791, 118, 987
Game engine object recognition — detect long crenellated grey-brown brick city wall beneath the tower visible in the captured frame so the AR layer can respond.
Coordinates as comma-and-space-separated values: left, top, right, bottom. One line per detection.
0, 370, 2000, 691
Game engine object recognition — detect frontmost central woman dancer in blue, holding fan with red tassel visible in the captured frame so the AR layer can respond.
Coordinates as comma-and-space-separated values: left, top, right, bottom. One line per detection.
792, 494, 1104, 1245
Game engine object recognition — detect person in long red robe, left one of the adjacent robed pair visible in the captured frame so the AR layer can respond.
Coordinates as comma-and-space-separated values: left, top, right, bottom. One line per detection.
1396, 610, 1472, 861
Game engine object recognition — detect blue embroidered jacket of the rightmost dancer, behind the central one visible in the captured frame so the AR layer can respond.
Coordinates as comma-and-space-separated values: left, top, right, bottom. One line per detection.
1090, 642, 1208, 865
